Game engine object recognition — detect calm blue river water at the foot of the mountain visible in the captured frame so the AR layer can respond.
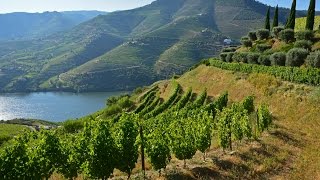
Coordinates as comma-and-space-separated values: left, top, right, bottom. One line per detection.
0, 92, 125, 122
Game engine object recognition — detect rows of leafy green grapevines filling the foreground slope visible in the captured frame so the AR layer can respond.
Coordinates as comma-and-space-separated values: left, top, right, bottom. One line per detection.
0, 80, 272, 179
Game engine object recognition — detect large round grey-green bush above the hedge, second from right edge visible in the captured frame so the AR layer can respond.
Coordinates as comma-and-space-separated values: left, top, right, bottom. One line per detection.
286, 48, 309, 67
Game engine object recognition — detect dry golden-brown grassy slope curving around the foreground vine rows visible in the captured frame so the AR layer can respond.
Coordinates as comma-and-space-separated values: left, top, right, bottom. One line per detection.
146, 65, 320, 179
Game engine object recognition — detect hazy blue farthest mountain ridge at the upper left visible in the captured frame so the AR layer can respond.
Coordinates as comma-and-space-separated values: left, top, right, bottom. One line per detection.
0, 11, 106, 40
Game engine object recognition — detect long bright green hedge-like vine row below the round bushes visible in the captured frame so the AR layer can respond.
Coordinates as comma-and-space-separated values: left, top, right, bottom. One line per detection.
210, 58, 320, 85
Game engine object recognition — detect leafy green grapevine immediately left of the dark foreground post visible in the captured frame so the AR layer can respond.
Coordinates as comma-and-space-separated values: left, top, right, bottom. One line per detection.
112, 114, 139, 177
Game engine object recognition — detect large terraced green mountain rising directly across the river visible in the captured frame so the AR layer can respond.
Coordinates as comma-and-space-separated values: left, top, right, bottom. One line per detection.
0, 0, 312, 92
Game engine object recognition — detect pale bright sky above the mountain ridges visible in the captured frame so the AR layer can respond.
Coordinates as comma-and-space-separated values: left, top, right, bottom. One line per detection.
0, 0, 320, 13
